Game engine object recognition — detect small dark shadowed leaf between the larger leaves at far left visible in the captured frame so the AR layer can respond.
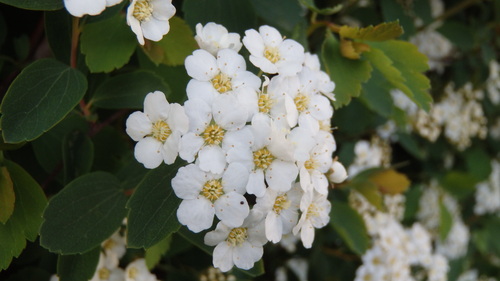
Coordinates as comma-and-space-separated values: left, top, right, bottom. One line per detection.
62, 130, 94, 182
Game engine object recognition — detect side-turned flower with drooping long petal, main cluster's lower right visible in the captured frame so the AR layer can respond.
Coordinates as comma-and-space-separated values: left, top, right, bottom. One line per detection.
293, 190, 331, 248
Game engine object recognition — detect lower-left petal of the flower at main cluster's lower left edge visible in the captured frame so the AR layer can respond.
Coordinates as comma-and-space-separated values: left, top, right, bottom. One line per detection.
177, 196, 215, 233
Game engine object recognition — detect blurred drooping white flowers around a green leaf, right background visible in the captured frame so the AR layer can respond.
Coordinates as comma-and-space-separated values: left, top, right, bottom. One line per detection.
417, 182, 470, 259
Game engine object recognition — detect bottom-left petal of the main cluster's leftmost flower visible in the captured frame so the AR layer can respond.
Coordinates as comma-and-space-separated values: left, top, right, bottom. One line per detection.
134, 137, 163, 169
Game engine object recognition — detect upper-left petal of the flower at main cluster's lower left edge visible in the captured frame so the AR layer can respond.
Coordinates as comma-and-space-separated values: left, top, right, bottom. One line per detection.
172, 164, 207, 199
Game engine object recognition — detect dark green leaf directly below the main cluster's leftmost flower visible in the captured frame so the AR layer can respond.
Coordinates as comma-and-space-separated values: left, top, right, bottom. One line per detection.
127, 161, 182, 249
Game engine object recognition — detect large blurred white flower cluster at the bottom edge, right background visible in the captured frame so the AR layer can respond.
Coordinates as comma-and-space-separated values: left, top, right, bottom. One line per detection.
349, 192, 448, 281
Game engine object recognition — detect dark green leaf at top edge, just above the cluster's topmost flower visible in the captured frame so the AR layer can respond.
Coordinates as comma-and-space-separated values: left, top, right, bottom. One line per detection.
182, 0, 257, 34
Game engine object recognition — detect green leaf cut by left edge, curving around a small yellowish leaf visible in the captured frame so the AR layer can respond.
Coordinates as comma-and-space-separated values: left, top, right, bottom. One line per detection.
0, 160, 47, 270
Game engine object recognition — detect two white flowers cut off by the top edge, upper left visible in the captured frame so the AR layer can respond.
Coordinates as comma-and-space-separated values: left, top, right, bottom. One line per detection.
64, 0, 176, 45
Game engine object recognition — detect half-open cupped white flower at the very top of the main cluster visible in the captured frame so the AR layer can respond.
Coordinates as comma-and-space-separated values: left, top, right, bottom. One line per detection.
194, 22, 243, 56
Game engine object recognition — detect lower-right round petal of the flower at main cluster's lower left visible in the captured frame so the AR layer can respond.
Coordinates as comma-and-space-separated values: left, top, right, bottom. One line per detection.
214, 192, 250, 227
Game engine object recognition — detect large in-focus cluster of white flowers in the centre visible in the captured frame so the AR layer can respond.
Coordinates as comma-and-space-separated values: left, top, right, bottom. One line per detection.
127, 23, 347, 272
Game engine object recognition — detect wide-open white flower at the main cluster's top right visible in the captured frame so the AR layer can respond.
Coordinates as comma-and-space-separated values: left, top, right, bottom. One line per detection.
243, 25, 305, 76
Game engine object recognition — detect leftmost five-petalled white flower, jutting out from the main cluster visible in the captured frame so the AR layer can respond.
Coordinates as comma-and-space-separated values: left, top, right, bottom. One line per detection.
126, 91, 189, 169
